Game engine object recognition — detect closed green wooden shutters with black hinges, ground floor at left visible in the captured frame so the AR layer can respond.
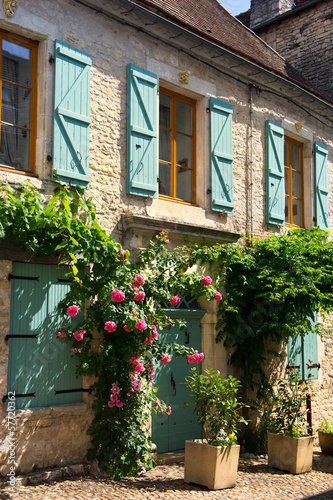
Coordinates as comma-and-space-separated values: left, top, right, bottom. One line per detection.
7, 263, 82, 409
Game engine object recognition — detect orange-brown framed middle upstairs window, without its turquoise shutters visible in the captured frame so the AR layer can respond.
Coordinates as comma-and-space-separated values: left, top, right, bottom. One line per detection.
158, 89, 195, 203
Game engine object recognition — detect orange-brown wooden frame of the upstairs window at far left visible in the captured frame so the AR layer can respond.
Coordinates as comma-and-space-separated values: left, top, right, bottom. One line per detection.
0, 29, 38, 176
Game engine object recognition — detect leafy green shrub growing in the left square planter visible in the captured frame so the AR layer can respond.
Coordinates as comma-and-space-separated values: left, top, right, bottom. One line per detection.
186, 367, 247, 446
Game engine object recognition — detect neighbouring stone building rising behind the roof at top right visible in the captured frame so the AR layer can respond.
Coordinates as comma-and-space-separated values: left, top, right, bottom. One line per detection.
237, 0, 333, 99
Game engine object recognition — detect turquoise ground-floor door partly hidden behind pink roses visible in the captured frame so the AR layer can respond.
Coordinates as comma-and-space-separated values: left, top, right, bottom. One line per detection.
152, 311, 202, 453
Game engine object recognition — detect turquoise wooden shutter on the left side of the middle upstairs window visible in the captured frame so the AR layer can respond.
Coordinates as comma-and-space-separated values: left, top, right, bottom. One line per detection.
127, 64, 158, 198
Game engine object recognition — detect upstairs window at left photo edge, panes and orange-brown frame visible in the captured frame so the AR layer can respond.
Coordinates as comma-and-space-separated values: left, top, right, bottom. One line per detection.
0, 30, 38, 172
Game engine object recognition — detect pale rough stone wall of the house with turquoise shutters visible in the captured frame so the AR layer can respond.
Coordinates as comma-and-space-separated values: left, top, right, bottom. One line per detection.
0, 0, 333, 473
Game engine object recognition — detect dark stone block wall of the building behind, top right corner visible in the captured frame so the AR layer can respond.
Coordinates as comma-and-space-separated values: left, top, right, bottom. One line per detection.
252, 0, 333, 99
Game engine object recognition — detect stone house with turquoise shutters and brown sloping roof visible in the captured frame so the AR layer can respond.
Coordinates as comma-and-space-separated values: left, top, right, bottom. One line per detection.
0, 0, 333, 474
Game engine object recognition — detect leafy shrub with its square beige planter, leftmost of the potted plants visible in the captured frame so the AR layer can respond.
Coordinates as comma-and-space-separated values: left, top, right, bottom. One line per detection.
184, 367, 247, 490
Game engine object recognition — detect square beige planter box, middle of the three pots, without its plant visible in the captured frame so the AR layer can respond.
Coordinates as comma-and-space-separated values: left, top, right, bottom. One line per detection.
268, 432, 315, 474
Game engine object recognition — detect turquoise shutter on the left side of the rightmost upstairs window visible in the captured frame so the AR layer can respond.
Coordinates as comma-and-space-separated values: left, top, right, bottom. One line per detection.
266, 120, 285, 226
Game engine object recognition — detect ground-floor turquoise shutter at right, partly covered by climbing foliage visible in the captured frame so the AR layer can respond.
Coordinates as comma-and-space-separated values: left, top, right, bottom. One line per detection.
288, 315, 318, 380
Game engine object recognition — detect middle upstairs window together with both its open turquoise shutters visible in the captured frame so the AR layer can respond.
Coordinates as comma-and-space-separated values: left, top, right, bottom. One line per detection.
127, 64, 234, 213
